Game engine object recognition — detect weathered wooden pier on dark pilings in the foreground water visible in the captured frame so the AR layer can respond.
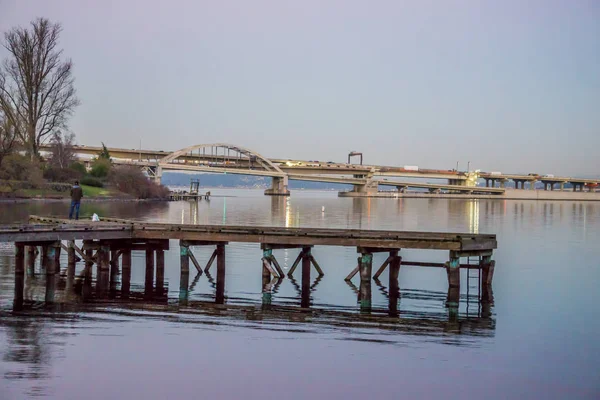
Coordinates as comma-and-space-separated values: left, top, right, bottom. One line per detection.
0, 216, 497, 313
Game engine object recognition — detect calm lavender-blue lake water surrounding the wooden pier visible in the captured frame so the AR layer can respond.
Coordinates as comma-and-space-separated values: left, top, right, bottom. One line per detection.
0, 190, 600, 400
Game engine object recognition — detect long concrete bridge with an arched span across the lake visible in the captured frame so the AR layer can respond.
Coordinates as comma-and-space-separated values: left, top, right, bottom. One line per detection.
42, 143, 600, 196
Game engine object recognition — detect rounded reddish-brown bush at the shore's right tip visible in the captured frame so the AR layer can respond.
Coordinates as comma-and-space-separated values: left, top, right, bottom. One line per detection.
110, 166, 169, 199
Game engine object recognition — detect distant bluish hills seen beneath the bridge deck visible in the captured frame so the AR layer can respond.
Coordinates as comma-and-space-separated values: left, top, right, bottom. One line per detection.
162, 172, 352, 190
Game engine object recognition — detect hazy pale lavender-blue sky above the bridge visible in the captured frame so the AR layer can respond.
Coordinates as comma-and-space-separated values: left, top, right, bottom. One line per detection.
0, 0, 600, 175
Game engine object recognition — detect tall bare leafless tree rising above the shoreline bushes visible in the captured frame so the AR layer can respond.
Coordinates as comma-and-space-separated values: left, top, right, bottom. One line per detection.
0, 18, 79, 159
